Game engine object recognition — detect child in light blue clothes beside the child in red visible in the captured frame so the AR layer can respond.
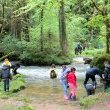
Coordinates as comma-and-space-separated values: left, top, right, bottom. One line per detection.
60, 65, 69, 100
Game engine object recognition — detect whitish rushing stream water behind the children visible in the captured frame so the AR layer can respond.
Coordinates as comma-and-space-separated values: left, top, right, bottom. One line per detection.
0, 57, 89, 83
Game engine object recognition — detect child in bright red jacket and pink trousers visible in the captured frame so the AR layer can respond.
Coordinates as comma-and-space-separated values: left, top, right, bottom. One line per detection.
66, 67, 77, 101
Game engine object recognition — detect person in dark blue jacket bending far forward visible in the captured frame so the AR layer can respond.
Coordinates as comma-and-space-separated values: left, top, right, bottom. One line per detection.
84, 67, 103, 88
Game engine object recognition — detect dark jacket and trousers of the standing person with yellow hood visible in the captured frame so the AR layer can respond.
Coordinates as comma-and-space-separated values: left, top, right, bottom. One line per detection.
0, 65, 12, 92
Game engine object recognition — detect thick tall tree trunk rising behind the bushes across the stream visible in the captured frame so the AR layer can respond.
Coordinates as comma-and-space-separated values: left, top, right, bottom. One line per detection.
59, 0, 68, 55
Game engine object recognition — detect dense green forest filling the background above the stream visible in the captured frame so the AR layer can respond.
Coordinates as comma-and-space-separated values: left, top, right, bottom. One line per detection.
0, 0, 110, 65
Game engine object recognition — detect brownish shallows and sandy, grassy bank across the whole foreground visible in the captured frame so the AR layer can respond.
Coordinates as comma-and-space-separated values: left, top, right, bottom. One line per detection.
0, 79, 110, 110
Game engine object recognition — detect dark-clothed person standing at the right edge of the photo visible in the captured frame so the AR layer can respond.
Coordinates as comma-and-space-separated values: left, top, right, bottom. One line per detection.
104, 61, 110, 90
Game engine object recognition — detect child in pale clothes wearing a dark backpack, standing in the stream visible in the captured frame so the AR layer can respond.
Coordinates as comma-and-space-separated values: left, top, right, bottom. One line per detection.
49, 64, 57, 87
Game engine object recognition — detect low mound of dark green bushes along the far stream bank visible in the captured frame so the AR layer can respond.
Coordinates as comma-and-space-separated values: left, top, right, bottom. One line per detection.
22, 51, 72, 65
